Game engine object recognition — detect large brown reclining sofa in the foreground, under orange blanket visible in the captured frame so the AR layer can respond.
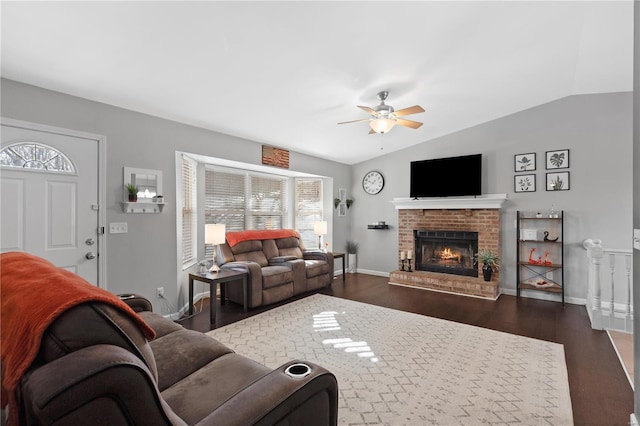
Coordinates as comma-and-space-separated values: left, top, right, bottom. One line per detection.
12, 298, 337, 425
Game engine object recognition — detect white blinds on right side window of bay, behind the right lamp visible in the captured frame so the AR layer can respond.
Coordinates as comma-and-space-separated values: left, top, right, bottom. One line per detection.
295, 178, 323, 248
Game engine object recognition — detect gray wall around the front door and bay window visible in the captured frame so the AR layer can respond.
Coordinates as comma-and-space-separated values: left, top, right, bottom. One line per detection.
1, 79, 351, 313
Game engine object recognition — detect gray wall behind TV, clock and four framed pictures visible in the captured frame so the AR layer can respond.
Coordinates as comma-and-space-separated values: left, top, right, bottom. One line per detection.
351, 92, 633, 302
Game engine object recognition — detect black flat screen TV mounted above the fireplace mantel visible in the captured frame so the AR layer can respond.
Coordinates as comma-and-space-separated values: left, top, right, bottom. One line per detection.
410, 154, 482, 198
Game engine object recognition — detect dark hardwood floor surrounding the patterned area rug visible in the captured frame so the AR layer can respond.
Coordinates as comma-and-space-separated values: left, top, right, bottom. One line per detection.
179, 274, 633, 425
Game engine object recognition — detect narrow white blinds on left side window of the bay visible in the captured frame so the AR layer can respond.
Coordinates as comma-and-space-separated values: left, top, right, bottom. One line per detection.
182, 156, 197, 266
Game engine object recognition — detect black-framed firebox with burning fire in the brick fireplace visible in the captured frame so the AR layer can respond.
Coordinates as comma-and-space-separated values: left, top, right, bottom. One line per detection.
413, 230, 478, 277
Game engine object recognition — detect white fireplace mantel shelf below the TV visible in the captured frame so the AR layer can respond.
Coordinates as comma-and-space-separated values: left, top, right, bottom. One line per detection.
391, 194, 507, 210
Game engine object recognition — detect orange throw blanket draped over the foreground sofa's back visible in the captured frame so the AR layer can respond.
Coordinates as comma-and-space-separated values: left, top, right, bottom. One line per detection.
0, 252, 155, 424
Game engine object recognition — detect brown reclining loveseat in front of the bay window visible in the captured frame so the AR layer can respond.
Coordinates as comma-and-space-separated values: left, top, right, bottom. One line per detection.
216, 230, 333, 308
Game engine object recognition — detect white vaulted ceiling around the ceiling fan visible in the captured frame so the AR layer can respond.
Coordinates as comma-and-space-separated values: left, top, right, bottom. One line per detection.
1, 0, 633, 164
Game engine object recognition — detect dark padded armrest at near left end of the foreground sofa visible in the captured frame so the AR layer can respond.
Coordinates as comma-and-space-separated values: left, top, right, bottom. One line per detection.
21, 345, 185, 425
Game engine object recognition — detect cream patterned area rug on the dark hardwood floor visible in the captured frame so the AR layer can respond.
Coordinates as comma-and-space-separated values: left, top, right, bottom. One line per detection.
207, 294, 573, 425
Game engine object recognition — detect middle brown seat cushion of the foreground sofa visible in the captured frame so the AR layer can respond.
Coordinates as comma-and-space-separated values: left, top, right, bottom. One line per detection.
150, 329, 233, 391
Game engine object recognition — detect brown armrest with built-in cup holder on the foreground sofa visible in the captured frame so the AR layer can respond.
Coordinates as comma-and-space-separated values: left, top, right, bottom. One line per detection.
198, 361, 338, 425
